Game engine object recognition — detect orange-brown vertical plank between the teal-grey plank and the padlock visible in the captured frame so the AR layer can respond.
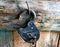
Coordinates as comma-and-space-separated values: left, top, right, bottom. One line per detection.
14, 31, 30, 47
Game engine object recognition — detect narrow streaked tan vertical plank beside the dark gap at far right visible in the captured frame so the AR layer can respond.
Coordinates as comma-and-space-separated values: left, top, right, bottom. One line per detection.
50, 32, 59, 47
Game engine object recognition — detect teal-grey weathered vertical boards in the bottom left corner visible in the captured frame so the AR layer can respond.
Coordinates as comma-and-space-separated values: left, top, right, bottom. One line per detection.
0, 30, 13, 47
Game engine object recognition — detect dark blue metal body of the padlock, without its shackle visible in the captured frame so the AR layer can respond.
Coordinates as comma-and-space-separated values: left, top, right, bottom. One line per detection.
18, 21, 40, 43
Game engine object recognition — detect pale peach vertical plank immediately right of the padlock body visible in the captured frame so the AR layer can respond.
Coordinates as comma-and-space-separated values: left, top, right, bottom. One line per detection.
37, 32, 50, 47
